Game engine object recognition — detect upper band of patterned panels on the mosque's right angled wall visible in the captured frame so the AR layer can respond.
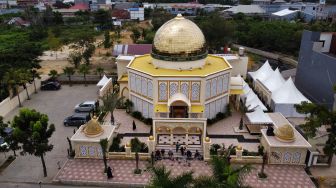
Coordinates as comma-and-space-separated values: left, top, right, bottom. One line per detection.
205, 73, 230, 100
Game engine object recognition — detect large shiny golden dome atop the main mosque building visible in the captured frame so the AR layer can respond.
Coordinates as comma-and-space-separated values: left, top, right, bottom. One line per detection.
152, 14, 207, 61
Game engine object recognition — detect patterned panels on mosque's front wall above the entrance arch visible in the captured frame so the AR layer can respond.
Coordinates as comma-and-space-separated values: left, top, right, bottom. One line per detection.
158, 80, 201, 102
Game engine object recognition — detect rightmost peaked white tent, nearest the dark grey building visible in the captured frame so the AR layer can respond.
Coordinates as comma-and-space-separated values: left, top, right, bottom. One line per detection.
271, 78, 310, 117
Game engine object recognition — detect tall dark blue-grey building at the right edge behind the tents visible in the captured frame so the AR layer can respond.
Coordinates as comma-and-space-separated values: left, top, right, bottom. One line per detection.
295, 31, 336, 109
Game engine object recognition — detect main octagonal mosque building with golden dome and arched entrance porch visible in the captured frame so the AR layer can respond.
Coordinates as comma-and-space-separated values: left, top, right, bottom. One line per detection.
117, 15, 242, 148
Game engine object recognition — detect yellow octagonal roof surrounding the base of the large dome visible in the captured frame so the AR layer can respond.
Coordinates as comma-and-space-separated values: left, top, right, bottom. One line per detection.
128, 54, 232, 77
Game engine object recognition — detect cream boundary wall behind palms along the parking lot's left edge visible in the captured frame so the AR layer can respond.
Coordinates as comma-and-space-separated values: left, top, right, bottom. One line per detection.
0, 76, 49, 117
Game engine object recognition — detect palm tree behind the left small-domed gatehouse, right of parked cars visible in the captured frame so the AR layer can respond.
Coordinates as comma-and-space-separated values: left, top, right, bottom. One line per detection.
101, 92, 124, 124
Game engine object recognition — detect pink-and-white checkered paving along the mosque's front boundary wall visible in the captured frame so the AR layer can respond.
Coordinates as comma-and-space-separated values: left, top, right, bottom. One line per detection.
54, 159, 315, 188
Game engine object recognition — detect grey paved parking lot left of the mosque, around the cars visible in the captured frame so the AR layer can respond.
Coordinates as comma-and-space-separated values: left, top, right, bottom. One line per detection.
0, 85, 97, 184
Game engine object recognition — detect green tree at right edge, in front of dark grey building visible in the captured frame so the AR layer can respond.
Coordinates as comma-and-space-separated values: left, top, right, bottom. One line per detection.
295, 101, 336, 163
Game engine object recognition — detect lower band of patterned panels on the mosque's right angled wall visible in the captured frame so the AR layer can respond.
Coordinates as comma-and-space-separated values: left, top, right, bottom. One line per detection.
204, 95, 228, 119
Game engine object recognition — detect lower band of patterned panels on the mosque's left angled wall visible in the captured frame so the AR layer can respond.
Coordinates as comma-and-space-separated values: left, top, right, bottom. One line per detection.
131, 95, 153, 118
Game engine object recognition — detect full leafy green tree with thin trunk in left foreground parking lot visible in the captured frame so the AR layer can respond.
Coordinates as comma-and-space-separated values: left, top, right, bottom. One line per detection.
12, 108, 55, 177
